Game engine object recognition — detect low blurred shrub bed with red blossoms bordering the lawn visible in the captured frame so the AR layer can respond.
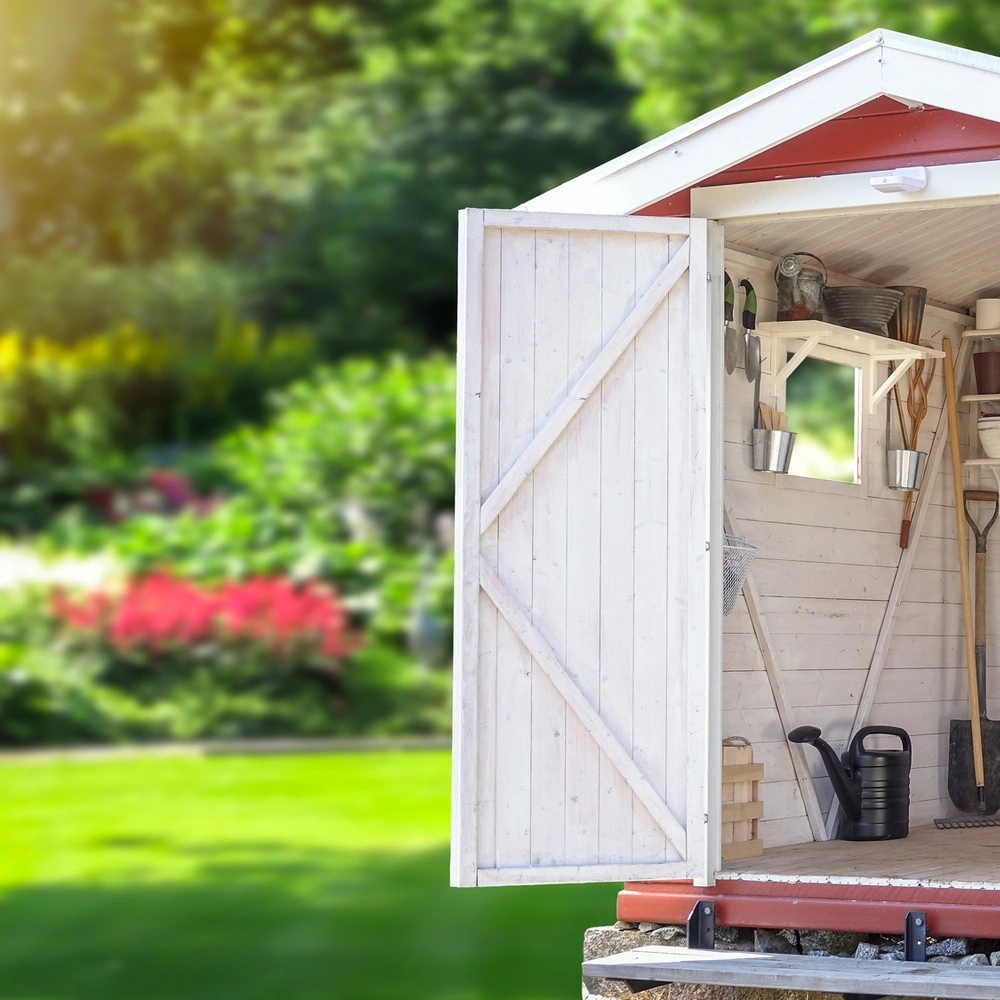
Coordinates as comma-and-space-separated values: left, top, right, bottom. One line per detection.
0, 575, 449, 745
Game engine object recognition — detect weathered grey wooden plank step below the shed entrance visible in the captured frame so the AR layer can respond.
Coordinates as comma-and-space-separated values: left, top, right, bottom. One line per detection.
583, 946, 1000, 1000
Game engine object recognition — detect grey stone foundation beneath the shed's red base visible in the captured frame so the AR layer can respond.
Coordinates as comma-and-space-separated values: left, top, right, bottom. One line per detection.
583, 920, 1000, 1000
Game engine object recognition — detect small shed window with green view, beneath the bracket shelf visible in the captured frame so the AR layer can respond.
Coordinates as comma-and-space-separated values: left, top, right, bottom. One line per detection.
785, 357, 861, 483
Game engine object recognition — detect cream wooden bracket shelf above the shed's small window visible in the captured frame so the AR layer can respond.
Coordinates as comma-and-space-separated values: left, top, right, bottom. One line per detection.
760, 320, 944, 413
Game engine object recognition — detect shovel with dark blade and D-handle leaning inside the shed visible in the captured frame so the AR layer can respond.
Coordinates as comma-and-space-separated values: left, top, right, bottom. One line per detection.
948, 490, 1000, 826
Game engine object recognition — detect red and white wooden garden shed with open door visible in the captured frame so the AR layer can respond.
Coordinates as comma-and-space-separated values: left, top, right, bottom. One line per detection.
452, 30, 1000, 960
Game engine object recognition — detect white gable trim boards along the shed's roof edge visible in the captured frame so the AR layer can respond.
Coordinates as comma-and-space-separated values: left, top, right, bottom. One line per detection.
521, 29, 1000, 215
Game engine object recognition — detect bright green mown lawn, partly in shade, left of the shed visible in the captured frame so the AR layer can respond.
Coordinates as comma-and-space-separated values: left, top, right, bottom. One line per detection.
0, 752, 617, 1000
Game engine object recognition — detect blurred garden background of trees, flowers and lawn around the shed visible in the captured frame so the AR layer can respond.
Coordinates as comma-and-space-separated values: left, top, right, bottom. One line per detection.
0, 0, 1000, 1000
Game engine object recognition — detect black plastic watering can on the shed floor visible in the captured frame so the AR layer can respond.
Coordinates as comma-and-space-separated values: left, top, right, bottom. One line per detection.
788, 726, 910, 840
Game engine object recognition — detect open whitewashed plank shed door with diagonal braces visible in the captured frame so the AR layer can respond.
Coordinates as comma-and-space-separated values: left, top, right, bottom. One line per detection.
452, 209, 723, 885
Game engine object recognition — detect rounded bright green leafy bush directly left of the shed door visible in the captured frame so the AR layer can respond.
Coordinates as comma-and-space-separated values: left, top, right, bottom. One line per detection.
220, 357, 455, 546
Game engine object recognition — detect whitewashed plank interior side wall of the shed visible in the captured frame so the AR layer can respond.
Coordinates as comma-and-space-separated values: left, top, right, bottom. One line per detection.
722, 250, 976, 846
